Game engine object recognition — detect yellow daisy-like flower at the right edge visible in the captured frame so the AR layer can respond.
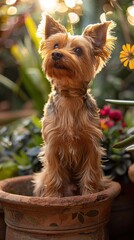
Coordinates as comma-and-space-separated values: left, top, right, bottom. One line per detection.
120, 43, 134, 69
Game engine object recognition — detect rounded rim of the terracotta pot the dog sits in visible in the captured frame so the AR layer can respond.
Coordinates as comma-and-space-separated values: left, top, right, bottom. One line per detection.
0, 175, 121, 207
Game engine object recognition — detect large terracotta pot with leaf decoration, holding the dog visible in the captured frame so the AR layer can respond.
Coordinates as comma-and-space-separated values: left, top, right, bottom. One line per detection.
0, 176, 120, 240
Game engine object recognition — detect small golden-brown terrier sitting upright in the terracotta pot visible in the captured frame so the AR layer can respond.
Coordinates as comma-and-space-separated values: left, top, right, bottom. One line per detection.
34, 15, 115, 197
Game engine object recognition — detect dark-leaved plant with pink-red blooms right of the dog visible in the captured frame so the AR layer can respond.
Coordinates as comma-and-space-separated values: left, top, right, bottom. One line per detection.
100, 105, 134, 182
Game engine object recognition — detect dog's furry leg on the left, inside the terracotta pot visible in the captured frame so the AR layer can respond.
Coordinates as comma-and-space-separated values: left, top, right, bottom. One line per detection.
34, 145, 64, 197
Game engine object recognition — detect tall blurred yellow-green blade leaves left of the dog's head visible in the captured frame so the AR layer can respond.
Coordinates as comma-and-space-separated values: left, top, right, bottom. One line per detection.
11, 15, 50, 112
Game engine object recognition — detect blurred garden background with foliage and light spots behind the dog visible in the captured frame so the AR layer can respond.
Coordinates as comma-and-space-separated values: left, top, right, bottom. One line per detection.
0, 0, 134, 181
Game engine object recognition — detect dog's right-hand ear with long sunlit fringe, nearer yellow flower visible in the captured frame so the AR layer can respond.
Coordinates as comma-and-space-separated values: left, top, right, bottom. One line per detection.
82, 21, 116, 73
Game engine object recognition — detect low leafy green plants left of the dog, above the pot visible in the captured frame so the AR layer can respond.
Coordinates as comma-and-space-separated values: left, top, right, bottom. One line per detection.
0, 117, 42, 179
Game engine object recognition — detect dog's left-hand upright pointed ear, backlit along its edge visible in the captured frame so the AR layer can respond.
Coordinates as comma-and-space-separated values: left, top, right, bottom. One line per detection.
37, 14, 67, 39
